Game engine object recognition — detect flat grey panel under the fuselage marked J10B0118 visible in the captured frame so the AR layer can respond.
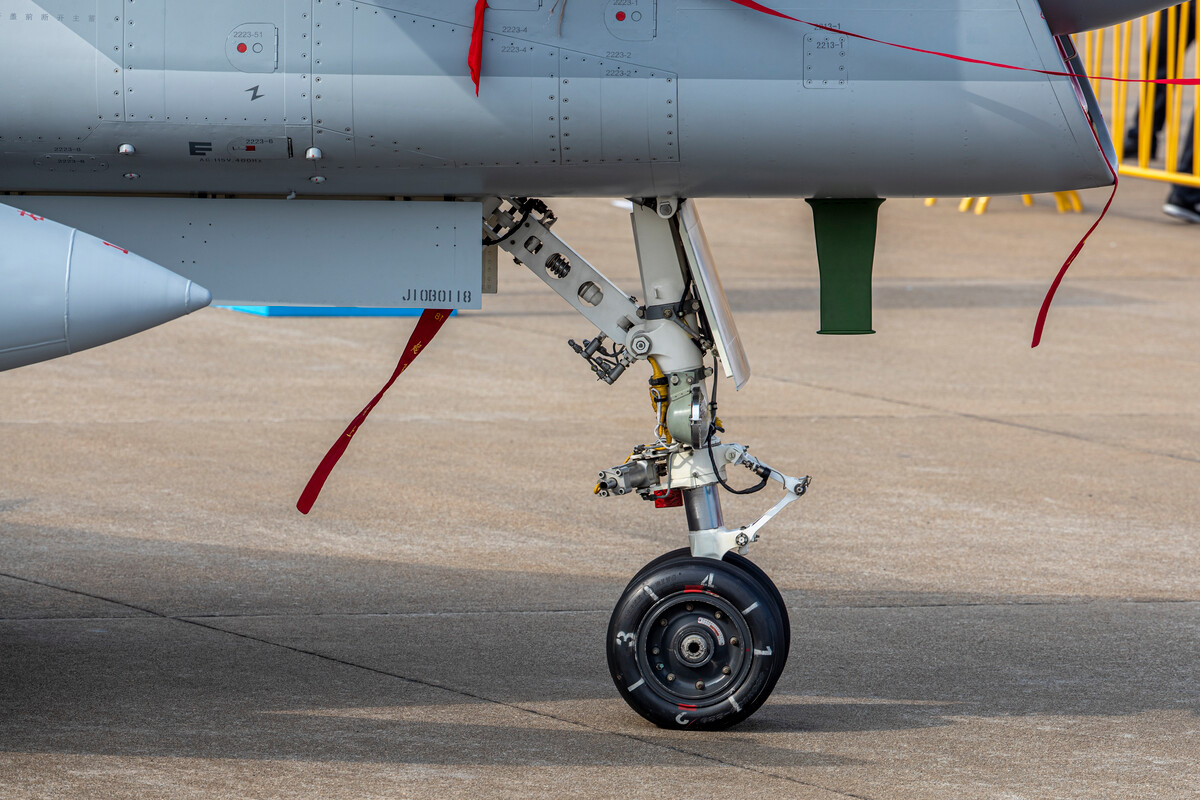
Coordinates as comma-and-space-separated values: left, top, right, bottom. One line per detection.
20, 197, 482, 308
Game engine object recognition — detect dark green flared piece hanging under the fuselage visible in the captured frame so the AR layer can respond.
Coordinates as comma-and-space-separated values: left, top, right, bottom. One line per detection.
805, 198, 883, 336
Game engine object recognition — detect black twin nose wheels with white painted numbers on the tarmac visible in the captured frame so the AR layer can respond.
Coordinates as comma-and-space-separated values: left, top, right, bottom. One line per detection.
606, 553, 787, 730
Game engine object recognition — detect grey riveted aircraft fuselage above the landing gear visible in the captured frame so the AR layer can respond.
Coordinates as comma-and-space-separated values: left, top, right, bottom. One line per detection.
0, 0, 1110, 197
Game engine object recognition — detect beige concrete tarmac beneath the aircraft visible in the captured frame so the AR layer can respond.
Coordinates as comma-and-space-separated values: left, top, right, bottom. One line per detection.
0, 180, 1200, 800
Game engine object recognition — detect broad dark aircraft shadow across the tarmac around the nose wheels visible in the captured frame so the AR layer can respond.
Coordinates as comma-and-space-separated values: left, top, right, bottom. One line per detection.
0, 524, 1200, 766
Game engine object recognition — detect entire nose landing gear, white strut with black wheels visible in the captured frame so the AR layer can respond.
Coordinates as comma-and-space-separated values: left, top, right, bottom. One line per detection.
484, 198, 809, 729
